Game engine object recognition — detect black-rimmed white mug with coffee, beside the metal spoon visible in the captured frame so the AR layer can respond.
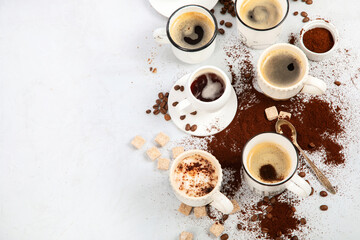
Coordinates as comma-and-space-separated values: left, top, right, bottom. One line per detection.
242, 133, 311, 197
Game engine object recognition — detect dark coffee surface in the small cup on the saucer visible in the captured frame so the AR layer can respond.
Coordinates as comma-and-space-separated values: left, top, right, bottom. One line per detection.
190, 73, 225, 102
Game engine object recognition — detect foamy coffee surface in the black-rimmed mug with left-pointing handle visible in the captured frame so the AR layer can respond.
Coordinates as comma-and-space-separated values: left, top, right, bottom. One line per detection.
170, 12, 215, 49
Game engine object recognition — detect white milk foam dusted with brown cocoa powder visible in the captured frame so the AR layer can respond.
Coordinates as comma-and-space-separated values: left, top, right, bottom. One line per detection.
173, 154, 219, 197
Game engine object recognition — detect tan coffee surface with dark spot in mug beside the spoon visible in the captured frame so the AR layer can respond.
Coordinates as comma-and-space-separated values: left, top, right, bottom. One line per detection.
247, 142, 291, 183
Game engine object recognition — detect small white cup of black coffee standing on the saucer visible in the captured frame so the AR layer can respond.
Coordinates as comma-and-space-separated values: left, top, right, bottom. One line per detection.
176, 66, 232, 112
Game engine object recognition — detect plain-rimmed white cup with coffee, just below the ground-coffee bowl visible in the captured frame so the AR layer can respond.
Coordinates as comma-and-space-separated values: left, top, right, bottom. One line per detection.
257, 43, 326, 100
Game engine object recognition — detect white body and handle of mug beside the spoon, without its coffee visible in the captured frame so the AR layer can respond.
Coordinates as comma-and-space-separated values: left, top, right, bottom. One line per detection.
242, 133, 311, 197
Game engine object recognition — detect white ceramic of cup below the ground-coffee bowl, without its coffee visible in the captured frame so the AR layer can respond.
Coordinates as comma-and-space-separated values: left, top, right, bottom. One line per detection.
257, 43, 326, 100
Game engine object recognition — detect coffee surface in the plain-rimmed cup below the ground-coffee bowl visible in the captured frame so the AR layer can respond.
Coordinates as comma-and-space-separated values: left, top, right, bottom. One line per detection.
260, 49, 306, 88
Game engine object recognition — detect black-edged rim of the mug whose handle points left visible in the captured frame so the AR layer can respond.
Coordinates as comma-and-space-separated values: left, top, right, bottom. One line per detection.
166, 4, 218, 52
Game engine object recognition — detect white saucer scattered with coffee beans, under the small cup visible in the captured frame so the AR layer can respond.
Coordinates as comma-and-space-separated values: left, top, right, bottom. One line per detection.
168, 74, 238, 137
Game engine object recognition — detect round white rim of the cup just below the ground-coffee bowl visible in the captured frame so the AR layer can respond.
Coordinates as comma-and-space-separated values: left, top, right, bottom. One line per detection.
257, 43, 309, 92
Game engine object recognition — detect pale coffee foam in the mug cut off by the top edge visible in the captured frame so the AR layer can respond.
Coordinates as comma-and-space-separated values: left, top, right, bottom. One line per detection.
239, 0, 283, 29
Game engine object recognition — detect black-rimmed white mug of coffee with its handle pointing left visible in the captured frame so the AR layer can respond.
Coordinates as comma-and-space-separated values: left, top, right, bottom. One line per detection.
153, 5, 217, 64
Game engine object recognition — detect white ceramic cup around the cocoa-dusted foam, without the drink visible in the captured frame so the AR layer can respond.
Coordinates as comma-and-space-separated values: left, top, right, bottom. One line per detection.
170, 150, 234, 214
